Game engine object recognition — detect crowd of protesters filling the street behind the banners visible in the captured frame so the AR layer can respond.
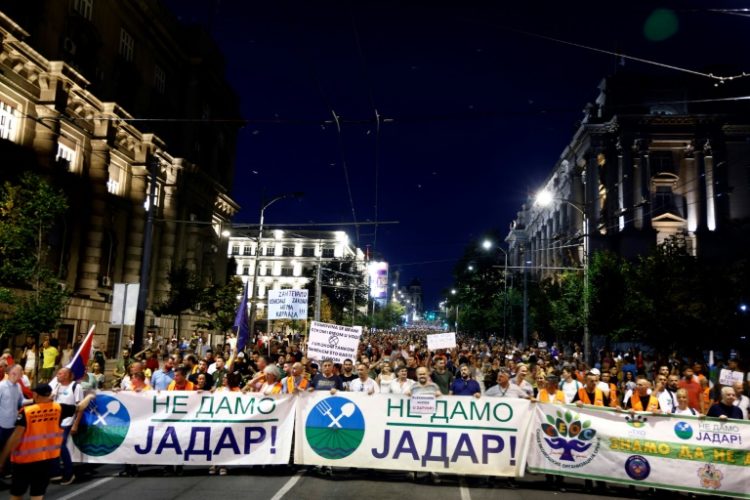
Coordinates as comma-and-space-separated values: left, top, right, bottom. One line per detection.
0, 330, 750, 491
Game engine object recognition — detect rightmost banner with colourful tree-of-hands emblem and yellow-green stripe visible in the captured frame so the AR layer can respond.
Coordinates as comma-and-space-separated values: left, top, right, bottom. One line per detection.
527, 403, 750, 498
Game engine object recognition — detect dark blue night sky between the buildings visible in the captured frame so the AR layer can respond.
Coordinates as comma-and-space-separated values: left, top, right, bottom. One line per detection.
166, 0, 750, 308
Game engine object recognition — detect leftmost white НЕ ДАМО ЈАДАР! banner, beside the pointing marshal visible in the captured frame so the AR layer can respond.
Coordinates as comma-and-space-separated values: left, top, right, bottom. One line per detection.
72, 391, 295, 465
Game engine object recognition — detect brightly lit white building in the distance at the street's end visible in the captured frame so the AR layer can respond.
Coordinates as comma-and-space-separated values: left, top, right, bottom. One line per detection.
228, 229, 367, 319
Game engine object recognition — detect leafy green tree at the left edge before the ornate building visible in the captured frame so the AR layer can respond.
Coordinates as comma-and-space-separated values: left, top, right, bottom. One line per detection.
0, 172, 69, 336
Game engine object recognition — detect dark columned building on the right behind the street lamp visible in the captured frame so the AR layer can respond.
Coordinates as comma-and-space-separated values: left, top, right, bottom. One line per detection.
506, 73, 750, 276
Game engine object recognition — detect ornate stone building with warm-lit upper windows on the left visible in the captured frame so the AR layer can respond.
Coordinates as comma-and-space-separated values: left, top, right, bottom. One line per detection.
0, 0, 239, 352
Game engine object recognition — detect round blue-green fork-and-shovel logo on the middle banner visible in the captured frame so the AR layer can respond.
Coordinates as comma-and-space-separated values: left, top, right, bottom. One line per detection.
305, 396, 365, 460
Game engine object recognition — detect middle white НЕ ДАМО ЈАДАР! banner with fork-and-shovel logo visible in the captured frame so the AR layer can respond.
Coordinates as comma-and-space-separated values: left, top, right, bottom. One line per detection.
294, 391, 530, 476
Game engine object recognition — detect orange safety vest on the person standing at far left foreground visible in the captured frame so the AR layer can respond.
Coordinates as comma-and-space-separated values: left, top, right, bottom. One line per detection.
10, 402, 63, 464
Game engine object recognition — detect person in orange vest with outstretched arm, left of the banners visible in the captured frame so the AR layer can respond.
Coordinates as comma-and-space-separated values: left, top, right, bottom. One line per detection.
0, 384, 95, 500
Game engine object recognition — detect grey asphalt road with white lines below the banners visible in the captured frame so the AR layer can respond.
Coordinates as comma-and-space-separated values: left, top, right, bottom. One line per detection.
7, 465, 708, 500
